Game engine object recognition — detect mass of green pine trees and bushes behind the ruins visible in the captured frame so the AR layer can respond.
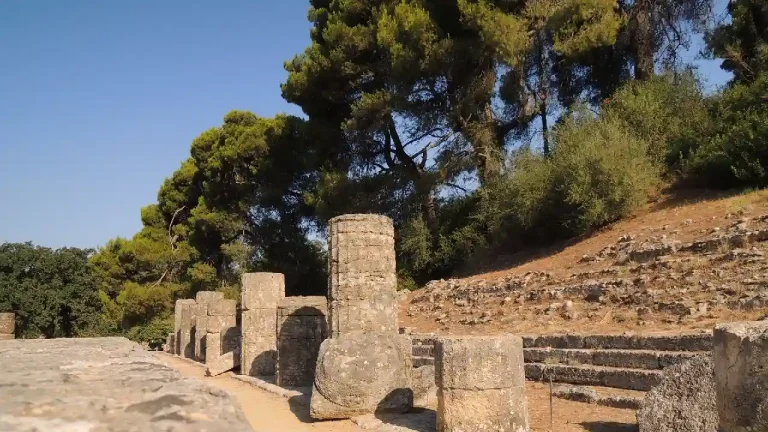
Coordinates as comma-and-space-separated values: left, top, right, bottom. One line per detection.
0, 0, 768, 342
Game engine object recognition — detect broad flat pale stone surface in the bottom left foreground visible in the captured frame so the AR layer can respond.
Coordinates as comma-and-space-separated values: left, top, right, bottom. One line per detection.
0, 338, 252, 432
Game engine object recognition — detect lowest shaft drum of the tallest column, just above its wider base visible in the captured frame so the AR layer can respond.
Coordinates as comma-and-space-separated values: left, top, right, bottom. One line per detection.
328, 296, 397, 337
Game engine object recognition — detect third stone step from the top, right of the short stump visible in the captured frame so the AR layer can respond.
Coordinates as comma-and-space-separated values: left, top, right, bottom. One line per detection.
525, 363, 662, 391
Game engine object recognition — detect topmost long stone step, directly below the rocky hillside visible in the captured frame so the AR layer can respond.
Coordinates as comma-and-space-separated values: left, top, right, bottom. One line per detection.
523, 332, 712, 351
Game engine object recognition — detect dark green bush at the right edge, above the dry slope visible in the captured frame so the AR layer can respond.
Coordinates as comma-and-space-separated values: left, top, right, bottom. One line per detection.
685, 77, 768, 188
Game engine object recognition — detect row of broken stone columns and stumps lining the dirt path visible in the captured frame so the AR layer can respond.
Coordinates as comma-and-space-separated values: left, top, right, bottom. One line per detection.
167, 215, 528, 432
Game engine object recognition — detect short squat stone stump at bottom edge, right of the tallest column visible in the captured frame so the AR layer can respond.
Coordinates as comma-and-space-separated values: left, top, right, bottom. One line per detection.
435, 335, 528, 432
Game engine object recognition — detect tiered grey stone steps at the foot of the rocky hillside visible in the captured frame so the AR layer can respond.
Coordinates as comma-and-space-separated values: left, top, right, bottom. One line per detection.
404, 333, 712, 398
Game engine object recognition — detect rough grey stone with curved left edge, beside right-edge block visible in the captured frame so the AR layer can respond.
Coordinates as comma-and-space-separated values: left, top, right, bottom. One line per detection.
637, 356, 717, 432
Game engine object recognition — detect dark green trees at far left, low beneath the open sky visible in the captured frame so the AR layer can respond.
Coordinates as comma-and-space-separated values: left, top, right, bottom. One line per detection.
0, 243, 101, 338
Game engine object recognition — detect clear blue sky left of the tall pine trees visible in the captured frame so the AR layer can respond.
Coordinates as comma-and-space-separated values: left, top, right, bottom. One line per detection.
0, 0, 727, 247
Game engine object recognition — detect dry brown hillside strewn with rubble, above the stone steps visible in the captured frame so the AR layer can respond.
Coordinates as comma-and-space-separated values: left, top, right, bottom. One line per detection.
400, 192, 768, 334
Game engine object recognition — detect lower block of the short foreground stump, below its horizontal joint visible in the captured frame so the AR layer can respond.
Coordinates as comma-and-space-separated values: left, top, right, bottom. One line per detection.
437, 387, 528, 432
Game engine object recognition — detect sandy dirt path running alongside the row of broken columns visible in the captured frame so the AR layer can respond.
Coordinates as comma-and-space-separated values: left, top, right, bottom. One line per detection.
157, 353, 362, 432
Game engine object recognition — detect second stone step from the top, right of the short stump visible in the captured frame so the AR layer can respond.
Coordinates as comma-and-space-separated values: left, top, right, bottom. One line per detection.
523, 348, 700, 370
